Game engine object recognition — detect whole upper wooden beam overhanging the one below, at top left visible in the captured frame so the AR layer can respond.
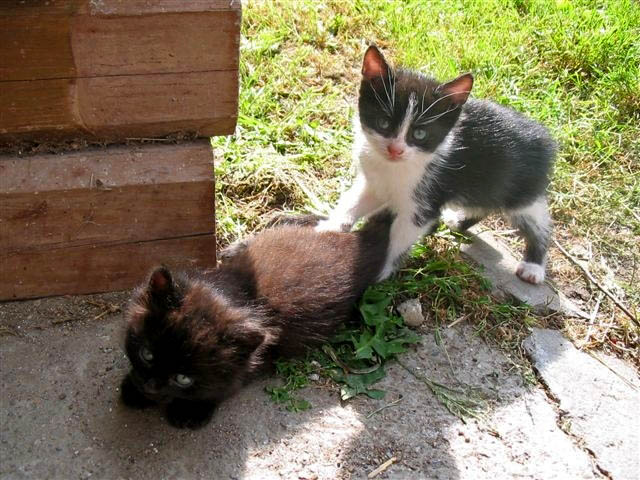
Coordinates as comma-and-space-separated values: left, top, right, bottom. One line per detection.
0, 0, 241, 144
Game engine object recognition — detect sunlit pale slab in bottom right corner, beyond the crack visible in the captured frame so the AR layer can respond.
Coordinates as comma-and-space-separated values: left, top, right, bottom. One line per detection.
524, 328, 640, 480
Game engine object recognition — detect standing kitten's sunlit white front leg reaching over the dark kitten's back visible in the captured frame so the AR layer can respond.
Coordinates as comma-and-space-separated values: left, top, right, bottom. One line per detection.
316, 174, 384, 232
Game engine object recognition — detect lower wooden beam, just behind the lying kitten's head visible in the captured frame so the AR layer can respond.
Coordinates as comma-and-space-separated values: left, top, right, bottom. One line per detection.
0, 140, 216, 300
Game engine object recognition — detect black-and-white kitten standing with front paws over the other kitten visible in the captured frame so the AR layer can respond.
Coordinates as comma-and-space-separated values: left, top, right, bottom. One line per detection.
316, 46, 556, 284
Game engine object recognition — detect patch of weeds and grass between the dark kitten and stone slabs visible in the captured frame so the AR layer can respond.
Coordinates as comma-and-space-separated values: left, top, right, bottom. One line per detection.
267, 236, 538, 419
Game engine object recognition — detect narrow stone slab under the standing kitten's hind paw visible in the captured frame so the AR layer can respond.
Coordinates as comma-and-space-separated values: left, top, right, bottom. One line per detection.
460, 226, 589, 318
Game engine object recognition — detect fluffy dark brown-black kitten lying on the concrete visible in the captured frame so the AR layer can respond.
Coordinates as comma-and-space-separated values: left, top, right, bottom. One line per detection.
122, 213, 392, 428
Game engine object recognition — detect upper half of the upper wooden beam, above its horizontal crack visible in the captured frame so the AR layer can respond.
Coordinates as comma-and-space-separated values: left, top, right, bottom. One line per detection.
0, 11, 239, 81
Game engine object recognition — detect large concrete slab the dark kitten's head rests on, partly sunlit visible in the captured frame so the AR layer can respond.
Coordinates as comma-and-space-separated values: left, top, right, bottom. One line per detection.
0, 296, 600, 480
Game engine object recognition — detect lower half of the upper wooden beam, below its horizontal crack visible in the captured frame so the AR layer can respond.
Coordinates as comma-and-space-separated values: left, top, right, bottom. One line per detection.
0, 71, 238, 145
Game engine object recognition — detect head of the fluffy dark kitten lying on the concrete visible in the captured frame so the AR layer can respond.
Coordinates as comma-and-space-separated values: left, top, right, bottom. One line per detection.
125, 270, 262, 403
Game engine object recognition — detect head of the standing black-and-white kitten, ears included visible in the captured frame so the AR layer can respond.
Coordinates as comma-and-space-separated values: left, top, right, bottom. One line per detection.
358, 47, 472, 162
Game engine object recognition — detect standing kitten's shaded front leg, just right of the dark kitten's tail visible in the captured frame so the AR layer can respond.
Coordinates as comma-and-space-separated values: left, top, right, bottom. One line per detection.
378, 214, 438, 282
